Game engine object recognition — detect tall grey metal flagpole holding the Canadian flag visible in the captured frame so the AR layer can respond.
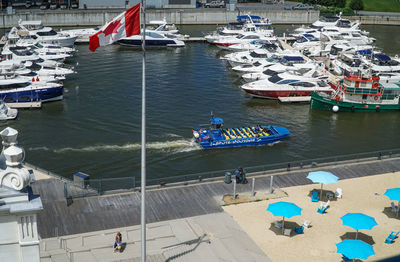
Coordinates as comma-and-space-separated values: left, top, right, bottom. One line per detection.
141, 0, 146, 262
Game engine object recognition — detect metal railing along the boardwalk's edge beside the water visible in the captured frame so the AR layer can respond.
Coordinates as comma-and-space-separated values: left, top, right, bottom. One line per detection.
41, 149, 400, 202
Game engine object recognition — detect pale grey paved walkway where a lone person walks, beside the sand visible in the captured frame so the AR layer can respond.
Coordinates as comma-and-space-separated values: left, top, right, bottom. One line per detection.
40, 212, 271, 262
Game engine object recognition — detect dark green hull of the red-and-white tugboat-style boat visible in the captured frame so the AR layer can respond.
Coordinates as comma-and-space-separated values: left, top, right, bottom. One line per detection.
310, 92, 400, 112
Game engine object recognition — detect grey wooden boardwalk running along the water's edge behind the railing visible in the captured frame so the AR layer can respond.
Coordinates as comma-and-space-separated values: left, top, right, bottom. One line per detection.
32, 158, 400, 238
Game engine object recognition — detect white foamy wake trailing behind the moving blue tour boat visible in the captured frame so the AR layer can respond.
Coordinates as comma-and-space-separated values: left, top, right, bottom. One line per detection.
29, 139, 201, 153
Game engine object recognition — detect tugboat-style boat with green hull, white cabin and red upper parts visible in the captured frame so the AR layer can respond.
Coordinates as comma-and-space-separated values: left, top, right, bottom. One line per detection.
310, 74, 400, 112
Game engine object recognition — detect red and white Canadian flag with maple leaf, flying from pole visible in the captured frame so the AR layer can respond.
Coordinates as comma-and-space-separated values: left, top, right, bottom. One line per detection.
89, 4, 140, 52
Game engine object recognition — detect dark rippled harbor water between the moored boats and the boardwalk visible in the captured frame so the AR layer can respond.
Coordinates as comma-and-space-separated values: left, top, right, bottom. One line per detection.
4, 26, 400, 178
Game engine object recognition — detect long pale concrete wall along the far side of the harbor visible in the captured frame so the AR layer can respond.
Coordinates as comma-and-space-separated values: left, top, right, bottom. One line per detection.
0, 8, 319, 28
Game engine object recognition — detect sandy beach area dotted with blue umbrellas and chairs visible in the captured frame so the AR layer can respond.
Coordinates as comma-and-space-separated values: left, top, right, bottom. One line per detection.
223, 172, 400, 262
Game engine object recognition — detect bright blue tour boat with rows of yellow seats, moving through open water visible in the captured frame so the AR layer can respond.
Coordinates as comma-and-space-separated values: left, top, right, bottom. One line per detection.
193, 116, 290, 149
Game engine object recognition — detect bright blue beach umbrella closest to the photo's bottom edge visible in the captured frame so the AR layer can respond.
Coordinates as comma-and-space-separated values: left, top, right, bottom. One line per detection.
336, 239, 375, 260
